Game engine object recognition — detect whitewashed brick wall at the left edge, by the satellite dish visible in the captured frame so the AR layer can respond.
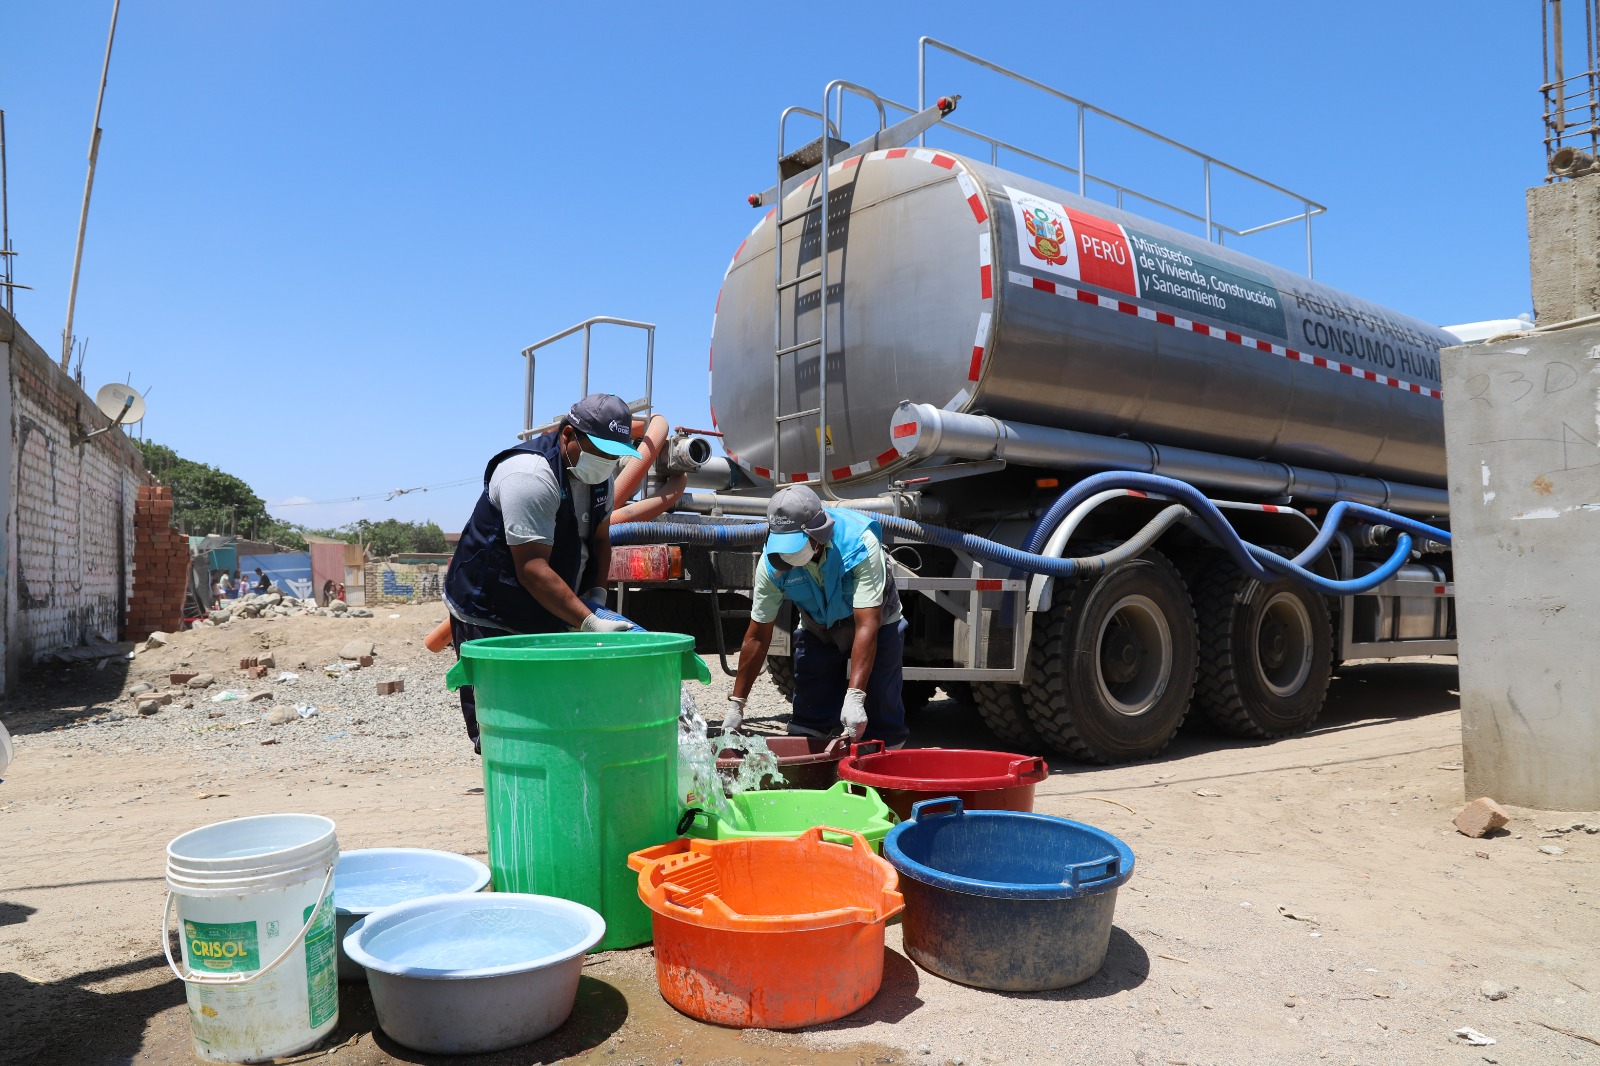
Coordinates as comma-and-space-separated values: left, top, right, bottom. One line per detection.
0, 311, 149, 691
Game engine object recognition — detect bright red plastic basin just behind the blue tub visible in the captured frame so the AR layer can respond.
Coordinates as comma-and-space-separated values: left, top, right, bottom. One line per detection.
838, 741, 1050, 820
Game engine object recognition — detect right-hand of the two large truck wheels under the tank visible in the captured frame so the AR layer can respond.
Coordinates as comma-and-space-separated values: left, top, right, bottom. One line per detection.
1195, 549, 1333, 736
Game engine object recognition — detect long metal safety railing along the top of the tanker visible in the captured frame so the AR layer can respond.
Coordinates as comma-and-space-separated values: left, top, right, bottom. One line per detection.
915, 37, 1328, 277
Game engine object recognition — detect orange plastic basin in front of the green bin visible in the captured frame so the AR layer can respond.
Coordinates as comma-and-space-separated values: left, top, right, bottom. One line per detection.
627, 826, 906, 1029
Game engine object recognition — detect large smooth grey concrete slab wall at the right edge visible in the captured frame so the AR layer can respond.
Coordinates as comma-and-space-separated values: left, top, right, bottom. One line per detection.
1440, 323, 1600, 810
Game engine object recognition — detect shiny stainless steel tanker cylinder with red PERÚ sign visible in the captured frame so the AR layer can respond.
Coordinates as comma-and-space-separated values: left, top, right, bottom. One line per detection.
710, 149, 1456, 485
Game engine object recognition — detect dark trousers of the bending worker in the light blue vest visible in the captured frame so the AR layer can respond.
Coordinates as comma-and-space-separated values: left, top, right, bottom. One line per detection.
789, 619, 909, 747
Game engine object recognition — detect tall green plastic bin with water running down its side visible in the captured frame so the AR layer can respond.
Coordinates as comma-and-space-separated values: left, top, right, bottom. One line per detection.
445, 632, 710, 951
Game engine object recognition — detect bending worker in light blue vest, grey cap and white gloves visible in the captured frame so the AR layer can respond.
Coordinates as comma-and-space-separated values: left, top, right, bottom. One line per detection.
722, 485, 907, 747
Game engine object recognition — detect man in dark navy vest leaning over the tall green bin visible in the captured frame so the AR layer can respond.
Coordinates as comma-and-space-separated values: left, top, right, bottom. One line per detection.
445, 392, 638, 747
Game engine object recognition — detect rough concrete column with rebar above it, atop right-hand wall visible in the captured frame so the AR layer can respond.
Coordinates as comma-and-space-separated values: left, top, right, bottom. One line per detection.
1528, 174, 1600, 325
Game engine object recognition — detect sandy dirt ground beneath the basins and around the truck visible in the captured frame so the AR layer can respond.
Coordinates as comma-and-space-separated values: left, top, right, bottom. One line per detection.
0, 607, 1600, 1066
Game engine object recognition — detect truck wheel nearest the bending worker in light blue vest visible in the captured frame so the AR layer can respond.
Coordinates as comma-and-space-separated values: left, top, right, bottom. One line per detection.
1024, 551, 1197, 762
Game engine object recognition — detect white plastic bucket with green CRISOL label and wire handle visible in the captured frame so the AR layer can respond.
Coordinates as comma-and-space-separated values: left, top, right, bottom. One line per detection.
162, 815, 339, 1063
